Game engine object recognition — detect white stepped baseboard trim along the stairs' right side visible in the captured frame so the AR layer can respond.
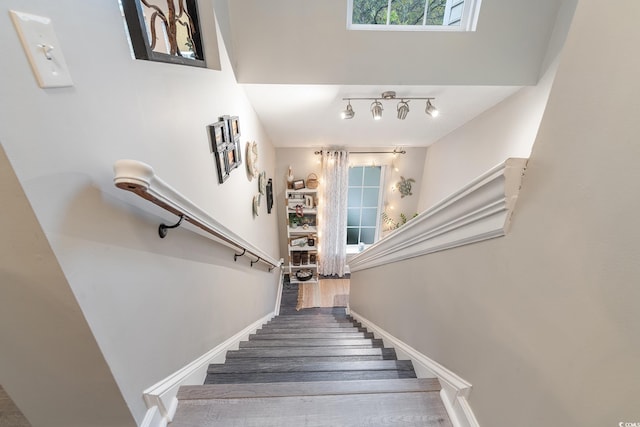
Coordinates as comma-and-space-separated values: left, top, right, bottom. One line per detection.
348, 308, 480, 427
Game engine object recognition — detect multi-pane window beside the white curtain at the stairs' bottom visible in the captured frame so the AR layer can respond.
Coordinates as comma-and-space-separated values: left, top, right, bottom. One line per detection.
347, 166, 383, 247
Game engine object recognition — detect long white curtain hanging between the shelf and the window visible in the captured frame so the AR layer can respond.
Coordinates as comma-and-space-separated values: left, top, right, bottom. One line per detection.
318, 150, 349, 277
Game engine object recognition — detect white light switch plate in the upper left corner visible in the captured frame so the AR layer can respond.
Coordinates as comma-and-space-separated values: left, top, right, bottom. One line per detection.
9, 10, 73, 87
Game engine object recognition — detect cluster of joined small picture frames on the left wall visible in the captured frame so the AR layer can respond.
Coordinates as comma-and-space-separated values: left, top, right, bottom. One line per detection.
209, 116, 242, 184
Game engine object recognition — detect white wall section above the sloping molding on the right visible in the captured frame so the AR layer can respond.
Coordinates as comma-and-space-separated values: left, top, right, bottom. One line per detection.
418, 0, 576, 212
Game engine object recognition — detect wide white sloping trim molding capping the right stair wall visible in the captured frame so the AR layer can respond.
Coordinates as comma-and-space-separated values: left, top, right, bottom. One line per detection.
349, 158, 527, 272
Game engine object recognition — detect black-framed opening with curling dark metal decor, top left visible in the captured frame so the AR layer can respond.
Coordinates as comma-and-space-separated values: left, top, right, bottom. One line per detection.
122, 0, 206, 67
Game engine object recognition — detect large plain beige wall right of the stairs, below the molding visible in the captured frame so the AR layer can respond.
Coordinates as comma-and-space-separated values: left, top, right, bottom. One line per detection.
350, 0, 640, 427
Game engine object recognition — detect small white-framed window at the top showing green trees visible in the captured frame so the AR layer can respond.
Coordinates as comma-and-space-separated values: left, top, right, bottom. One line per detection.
347, 0, 480, 31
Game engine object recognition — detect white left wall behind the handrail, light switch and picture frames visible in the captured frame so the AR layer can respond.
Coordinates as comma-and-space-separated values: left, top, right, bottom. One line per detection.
0, 0, 278, 427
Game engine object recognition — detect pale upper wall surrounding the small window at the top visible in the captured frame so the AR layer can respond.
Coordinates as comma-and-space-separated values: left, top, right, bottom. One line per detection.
229, 0, 561, 86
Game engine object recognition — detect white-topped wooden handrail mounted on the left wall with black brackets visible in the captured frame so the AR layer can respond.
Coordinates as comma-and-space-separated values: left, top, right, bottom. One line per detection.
113, 159, 282, 271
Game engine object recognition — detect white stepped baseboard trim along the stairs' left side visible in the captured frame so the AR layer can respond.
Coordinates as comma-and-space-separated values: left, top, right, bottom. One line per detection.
140, 312, 275, 427
